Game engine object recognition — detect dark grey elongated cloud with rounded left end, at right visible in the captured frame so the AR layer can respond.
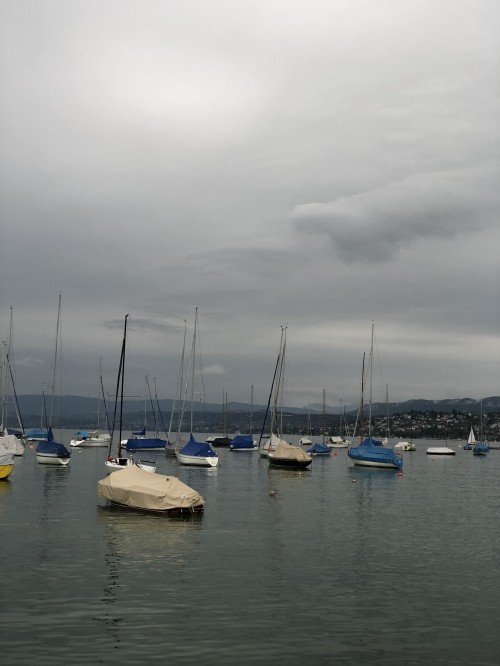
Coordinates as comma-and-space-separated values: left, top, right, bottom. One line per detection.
292, 163, 500, 263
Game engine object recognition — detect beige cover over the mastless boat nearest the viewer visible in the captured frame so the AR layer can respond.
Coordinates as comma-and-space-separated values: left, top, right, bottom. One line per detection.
97, 465, 205, 511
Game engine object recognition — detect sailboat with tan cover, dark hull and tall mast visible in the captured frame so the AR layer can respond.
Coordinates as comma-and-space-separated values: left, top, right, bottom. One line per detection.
267, 326, 312, 469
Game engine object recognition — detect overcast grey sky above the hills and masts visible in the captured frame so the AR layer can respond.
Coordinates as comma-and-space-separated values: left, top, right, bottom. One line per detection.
0, 0, 500, 407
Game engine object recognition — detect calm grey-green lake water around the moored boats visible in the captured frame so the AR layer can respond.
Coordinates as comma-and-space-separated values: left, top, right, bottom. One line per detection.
0, 431, 500, 666
